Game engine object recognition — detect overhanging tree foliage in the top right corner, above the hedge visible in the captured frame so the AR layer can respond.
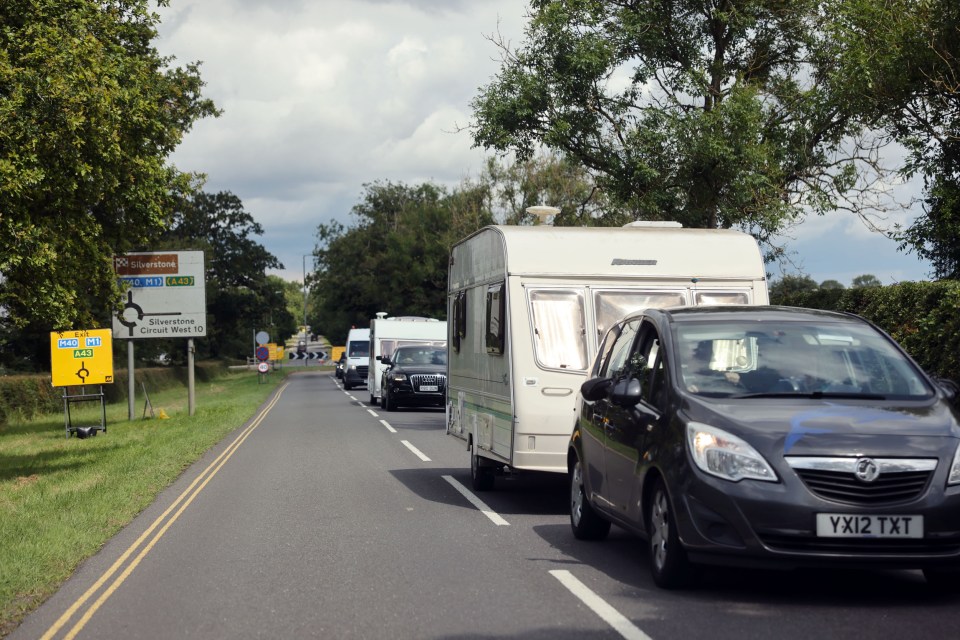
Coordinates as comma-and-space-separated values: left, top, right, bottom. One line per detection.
825, 0, 960, 278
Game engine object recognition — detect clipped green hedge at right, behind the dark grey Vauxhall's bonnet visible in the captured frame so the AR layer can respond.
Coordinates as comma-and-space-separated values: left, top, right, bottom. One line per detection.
771, 280, 960, 381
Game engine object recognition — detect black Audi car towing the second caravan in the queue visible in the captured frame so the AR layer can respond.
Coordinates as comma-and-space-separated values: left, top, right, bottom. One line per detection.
380, 345, 447, 411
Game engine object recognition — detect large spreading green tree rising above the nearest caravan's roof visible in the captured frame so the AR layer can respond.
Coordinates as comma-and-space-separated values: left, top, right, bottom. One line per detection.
472, 0, 880, 255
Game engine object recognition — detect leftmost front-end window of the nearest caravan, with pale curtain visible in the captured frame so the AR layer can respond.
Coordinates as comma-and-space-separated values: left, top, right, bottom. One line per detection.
530, 289, 588, 371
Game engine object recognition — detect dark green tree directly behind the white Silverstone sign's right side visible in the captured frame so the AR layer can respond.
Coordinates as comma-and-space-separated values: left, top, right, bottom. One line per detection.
158, 192, 296, 358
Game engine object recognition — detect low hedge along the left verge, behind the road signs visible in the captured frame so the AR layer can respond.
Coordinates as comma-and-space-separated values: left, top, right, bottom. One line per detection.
0, 361, 228, 427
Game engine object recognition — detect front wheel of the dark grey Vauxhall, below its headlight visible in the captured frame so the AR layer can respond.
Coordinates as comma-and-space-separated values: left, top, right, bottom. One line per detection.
647, 479, 696, 589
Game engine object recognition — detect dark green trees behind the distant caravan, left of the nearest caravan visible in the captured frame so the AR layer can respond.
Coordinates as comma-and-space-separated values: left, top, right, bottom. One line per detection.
308, 182, 493, 344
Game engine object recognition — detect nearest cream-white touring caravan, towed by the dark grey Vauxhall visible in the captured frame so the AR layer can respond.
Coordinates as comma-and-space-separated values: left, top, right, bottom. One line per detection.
447, 223, 768, 490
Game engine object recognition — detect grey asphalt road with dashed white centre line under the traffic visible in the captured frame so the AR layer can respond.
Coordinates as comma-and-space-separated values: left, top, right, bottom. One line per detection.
10, 371, 960, 640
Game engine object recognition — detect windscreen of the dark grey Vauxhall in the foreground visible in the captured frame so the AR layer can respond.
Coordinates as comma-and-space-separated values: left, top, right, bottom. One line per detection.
675, 319, 933, 399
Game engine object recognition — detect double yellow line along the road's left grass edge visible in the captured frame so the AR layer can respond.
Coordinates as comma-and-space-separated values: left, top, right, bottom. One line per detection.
41, 382, 288, 640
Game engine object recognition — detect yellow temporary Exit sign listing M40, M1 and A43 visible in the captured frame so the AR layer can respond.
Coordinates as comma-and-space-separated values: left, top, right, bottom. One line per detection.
50, 329, 113, 387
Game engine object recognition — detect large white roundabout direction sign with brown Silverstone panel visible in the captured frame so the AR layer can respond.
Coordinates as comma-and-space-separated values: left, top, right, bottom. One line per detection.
113, 251, 207, 338
